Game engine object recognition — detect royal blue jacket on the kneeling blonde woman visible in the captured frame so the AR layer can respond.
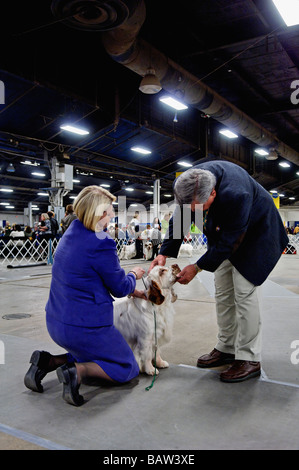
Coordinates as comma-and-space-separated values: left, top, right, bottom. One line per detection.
46, 220, 136, 327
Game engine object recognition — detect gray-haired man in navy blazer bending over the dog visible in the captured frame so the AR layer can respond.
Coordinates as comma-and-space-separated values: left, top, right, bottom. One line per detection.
150, 160, 288, 382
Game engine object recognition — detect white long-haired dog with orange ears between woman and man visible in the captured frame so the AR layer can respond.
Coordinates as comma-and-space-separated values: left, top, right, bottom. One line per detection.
114, 264, 181, 375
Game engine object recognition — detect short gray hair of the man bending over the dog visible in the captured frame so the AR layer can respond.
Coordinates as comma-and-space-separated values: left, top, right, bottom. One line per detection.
174, 168, 216, 206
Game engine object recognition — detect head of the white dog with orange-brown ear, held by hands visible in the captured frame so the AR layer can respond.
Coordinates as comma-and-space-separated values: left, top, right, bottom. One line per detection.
147, 264, 181, 305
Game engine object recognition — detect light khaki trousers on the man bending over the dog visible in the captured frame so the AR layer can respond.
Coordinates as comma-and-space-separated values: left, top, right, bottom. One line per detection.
215, 260, 261, 362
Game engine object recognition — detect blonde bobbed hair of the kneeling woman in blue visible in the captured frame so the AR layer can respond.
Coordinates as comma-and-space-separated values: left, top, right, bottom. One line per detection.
74, 185, 116, 232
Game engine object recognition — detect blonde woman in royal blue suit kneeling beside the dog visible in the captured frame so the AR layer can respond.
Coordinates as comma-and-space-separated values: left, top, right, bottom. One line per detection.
24, 186, 145, 406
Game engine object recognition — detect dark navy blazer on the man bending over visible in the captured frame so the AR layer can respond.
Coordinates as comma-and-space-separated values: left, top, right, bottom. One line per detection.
160, 160, 288, 285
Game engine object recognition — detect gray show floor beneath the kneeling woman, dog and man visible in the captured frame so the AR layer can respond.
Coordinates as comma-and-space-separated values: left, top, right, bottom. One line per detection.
0, 255, 299, 450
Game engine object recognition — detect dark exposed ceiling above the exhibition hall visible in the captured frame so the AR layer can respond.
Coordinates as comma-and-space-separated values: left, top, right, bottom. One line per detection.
0, 0, 299, 216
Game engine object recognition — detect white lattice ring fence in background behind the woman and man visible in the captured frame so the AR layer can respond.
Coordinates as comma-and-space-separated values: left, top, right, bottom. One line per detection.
0, 235, 299, 267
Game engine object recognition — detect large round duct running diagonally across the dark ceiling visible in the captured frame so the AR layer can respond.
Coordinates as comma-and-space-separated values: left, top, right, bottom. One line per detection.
102, 0, 299, 165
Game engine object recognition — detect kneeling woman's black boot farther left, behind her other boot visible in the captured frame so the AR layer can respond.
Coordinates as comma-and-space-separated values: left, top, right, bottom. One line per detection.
24, 351, 51, 393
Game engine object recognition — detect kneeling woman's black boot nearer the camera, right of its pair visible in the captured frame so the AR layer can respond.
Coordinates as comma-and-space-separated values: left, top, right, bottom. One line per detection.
56, 362, 84, 406
